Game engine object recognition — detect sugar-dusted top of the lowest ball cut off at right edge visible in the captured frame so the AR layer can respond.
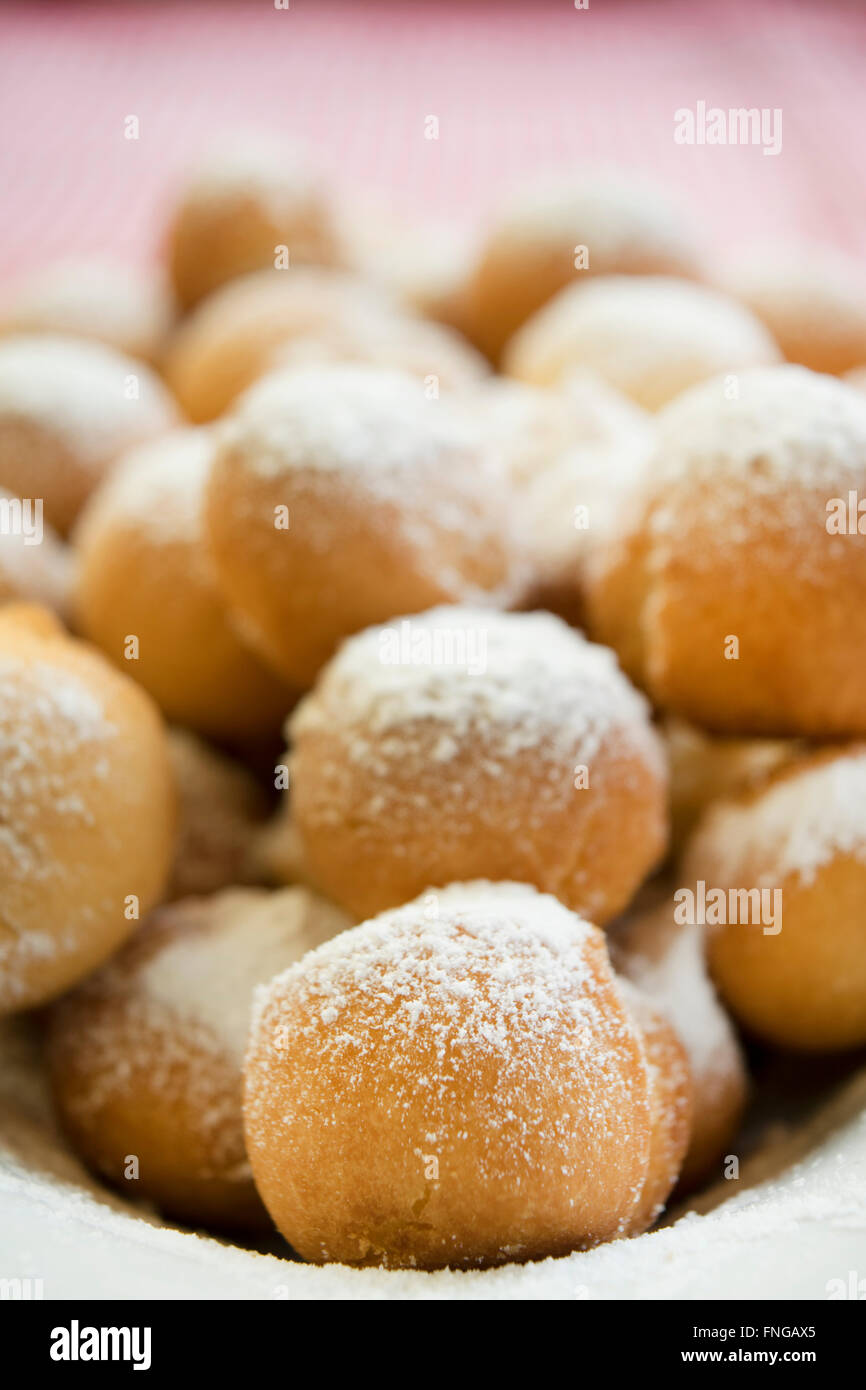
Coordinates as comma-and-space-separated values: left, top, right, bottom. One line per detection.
687, 744, 866, 888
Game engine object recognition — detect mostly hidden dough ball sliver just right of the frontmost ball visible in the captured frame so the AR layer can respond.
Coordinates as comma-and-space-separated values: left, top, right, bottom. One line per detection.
609, 901, 748, 1188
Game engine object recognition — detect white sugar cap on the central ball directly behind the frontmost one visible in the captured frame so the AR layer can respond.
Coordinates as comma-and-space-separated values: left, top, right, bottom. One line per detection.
289, 606, 662, 778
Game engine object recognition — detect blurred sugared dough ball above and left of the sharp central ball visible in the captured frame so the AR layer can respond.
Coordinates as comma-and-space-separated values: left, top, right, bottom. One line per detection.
206, 367, 524, 688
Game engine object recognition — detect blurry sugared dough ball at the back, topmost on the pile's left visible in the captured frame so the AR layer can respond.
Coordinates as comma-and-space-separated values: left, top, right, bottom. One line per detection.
168, 140, 338, 309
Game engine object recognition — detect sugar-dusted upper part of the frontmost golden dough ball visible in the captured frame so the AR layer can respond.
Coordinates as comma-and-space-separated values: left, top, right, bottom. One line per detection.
247, 883, 645, 1195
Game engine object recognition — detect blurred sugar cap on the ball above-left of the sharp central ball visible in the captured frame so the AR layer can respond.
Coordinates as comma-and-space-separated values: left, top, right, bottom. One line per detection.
217, 364, 523, 602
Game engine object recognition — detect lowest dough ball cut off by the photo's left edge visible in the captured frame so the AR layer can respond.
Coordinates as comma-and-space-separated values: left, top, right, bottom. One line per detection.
0, 603, 174, 1013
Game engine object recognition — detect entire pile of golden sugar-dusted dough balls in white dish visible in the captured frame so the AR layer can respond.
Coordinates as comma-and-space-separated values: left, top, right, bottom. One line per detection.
0, 147, 866, 1269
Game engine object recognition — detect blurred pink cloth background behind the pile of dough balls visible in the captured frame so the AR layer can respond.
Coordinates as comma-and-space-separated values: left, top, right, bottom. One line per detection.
0, 0, 866, 271
